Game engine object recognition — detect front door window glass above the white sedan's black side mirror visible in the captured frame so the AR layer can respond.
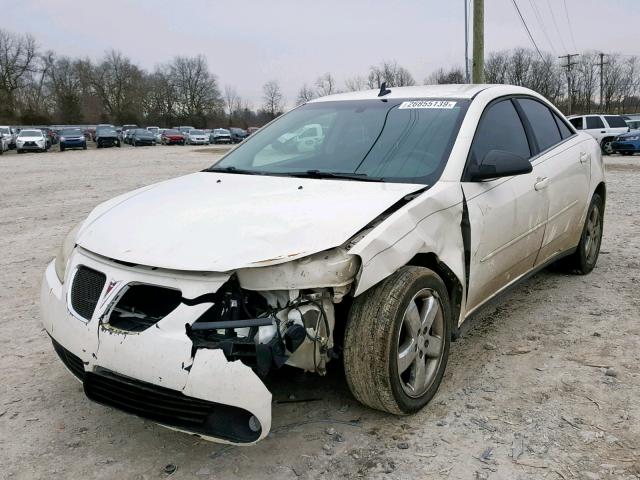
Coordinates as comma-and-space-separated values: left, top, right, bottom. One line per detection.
469, 100, 531, 169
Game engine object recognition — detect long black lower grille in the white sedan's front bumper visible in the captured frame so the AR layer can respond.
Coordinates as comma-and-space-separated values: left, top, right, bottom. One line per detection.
84, 369, 262, 443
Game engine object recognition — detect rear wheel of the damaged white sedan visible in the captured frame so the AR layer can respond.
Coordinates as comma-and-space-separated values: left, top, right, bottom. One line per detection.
559, 193, 604, 275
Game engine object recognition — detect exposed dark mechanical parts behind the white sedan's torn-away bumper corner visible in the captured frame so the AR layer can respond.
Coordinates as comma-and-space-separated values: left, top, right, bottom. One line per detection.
185, 277, 336, 376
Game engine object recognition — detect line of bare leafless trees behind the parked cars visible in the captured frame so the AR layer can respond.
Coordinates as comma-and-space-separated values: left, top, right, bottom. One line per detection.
0, 29, 640, 128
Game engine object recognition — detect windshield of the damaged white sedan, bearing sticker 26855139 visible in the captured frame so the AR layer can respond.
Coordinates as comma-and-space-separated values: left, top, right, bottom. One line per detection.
214, 99, 469, 184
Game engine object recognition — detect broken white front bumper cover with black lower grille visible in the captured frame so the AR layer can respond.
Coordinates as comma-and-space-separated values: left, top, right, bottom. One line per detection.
41, 253, 271, 445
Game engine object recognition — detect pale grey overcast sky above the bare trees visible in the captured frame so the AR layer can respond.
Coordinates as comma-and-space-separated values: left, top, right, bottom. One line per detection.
1, 0, 640, 106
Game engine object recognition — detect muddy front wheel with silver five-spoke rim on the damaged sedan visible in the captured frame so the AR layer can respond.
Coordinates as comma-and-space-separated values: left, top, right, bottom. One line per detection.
344, 267, 452, 415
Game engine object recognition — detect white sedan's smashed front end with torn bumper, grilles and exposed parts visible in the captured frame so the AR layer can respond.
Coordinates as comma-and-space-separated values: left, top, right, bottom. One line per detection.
42, 248, 360, 445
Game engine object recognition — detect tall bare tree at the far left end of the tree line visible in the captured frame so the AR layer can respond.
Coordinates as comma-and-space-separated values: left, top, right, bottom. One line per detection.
0, 29, 37, 118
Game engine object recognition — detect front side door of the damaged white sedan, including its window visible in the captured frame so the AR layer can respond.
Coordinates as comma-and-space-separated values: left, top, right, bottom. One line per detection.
462, 99, 549, 313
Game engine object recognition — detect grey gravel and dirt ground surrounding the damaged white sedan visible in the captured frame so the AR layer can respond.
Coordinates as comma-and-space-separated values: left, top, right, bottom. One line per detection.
0, 147, 640, 480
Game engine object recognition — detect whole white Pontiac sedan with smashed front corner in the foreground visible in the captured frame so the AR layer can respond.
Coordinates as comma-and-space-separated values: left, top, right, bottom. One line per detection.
42, 85, 606, 445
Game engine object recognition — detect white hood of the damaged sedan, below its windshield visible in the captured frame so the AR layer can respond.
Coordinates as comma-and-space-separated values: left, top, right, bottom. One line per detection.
76, 172, 424, 272
